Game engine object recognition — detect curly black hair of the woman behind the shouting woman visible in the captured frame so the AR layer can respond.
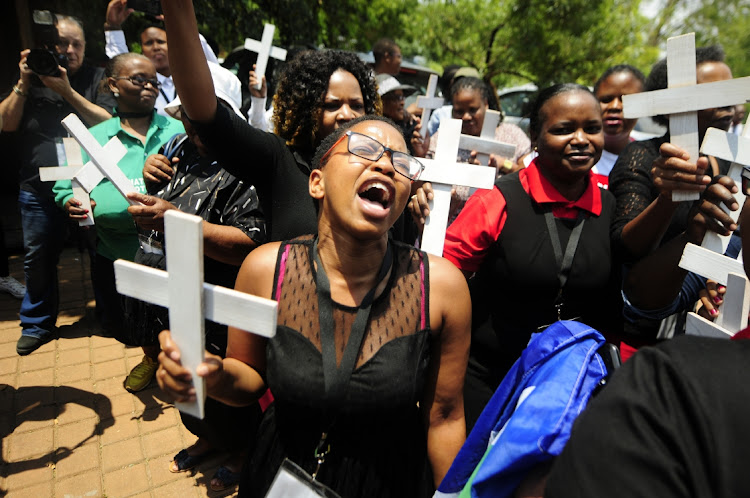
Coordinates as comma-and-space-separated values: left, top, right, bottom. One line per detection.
273, 50, 382, 153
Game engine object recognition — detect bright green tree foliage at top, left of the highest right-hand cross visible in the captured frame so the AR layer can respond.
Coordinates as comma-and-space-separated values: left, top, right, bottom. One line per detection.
409, 0, 656, 86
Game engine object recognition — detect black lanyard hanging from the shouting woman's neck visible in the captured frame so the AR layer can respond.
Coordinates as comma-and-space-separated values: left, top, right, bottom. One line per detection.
313, 238, 393, 412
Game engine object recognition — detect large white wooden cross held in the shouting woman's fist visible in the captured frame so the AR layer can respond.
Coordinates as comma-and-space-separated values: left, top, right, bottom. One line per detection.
115, 210, 277, 418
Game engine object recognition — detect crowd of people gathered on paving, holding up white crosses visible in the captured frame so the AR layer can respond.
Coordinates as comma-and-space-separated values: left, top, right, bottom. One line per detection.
0, 0, 750, 497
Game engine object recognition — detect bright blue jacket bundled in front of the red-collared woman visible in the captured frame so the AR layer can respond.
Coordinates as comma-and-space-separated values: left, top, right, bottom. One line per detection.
435, 321, 607, 498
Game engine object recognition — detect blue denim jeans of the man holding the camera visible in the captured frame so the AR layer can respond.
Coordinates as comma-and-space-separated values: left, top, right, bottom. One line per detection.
18, 190, 66, 338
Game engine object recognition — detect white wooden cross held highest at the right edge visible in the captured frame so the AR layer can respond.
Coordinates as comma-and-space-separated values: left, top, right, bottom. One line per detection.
622, 33, 750, 201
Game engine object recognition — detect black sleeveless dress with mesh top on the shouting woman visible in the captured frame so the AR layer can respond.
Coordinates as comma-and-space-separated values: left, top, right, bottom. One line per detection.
239, 238, 434, 498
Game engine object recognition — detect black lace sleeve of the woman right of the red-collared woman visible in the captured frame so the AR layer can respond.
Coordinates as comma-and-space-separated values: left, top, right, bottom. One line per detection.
609, 136, 667, 247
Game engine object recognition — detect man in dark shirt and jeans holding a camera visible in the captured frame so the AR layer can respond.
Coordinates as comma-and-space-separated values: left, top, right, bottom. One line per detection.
0, 14, 115, 355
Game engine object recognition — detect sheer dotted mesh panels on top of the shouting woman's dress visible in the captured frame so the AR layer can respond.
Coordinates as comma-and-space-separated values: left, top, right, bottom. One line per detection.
278, 244, 422, 367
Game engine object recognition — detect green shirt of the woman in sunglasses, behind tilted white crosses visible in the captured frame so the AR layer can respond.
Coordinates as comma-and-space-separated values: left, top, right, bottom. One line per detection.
52, 112, 185, 261
